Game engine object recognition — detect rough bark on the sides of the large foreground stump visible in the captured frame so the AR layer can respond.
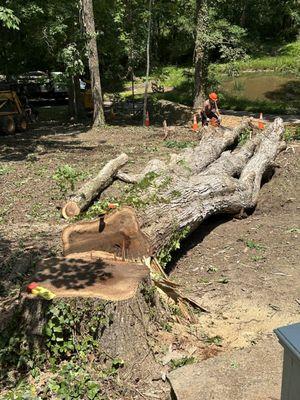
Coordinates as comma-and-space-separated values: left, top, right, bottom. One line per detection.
5, 278, 171, 382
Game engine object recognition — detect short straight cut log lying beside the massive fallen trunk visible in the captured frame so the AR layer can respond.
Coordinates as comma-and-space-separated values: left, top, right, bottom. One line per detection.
61, 153, 128, 219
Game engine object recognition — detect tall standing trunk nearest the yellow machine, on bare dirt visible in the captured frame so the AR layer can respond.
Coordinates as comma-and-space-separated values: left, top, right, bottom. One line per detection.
81, 0, 105, 127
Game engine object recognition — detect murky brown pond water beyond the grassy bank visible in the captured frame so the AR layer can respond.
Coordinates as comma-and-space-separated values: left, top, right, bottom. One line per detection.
220, 72, 300, 109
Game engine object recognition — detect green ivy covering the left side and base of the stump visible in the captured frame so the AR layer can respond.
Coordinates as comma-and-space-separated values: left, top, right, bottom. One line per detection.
0, 300, 124, 400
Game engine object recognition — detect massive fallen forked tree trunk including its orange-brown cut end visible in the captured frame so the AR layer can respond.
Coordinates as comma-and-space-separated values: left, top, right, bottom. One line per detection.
63, 119, 284, 262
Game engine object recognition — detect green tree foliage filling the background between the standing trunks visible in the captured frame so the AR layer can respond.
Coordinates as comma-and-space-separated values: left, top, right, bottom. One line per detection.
0, 0, 299, 104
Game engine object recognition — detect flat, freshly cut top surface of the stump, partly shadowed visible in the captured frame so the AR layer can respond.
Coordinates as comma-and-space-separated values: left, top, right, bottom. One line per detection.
34, 254, 149, 301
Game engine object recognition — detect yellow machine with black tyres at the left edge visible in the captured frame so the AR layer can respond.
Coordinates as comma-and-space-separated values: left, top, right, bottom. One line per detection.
0, 90, 28, 134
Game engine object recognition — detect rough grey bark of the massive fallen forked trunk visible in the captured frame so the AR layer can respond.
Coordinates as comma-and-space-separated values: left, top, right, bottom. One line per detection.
138, 119, 284, 255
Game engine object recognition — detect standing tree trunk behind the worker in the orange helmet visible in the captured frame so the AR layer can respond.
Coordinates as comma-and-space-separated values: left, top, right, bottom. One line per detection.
194, 0, 208, 109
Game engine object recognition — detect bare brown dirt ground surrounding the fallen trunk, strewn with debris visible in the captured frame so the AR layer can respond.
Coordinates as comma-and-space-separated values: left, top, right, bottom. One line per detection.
0, 108, 300, 399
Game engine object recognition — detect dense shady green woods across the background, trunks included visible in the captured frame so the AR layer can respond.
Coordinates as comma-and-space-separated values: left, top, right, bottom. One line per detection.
0, 0, 299, 115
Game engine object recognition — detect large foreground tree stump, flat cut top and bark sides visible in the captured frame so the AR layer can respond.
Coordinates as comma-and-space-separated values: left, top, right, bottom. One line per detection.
16, 274, 166, 379
